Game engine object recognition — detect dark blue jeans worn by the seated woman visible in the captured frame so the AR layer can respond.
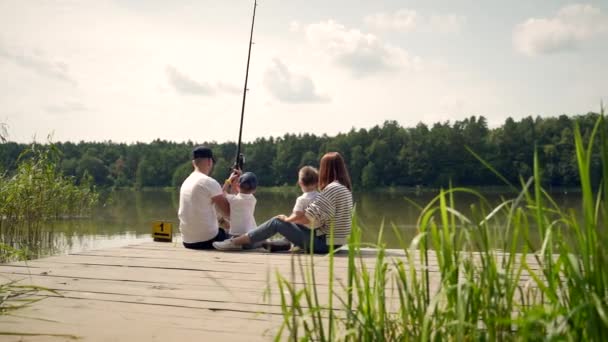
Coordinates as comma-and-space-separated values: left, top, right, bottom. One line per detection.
247, 218, 340, 253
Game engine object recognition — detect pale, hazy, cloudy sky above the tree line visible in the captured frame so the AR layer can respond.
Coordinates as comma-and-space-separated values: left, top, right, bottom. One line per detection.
0, 0, 608, 143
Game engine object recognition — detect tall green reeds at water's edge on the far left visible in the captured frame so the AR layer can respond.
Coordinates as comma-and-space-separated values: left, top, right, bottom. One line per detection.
0, 144, 98, 262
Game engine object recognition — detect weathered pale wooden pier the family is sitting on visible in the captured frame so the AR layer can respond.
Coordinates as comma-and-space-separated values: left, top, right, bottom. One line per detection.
0, 242, 540, 342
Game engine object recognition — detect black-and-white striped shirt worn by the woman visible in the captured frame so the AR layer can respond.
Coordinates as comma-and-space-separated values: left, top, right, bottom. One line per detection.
305, 181, 353, 245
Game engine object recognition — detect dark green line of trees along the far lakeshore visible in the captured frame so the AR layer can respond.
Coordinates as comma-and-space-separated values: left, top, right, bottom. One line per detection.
0, 113, 600, 189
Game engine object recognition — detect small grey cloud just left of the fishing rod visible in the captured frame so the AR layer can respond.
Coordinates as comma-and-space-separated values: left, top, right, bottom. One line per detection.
165, 65, 242, 96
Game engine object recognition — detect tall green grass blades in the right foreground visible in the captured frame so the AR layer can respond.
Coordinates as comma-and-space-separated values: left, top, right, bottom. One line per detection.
276, 109, 608, 341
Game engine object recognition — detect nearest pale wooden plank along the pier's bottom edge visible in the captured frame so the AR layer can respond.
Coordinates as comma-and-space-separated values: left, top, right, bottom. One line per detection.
0, 298, 280, 341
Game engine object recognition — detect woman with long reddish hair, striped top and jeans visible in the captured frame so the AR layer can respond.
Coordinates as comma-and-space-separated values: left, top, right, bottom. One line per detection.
213, 152, 353, 253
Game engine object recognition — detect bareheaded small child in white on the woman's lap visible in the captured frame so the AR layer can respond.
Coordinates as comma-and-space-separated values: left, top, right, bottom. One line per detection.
262, 166, 319, 252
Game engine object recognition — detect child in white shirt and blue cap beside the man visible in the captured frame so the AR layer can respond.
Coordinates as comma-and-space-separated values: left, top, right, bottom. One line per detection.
223, 172, 258, 237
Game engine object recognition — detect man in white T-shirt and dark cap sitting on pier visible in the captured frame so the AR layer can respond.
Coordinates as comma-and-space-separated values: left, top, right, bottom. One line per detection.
177, 146, 230, 249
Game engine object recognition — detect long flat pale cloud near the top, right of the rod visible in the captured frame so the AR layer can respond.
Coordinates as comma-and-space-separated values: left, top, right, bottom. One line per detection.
364, 9, 466, 33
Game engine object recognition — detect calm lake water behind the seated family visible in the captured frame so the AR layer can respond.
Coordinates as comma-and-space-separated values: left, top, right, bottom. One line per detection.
19, 190, 580, 260
